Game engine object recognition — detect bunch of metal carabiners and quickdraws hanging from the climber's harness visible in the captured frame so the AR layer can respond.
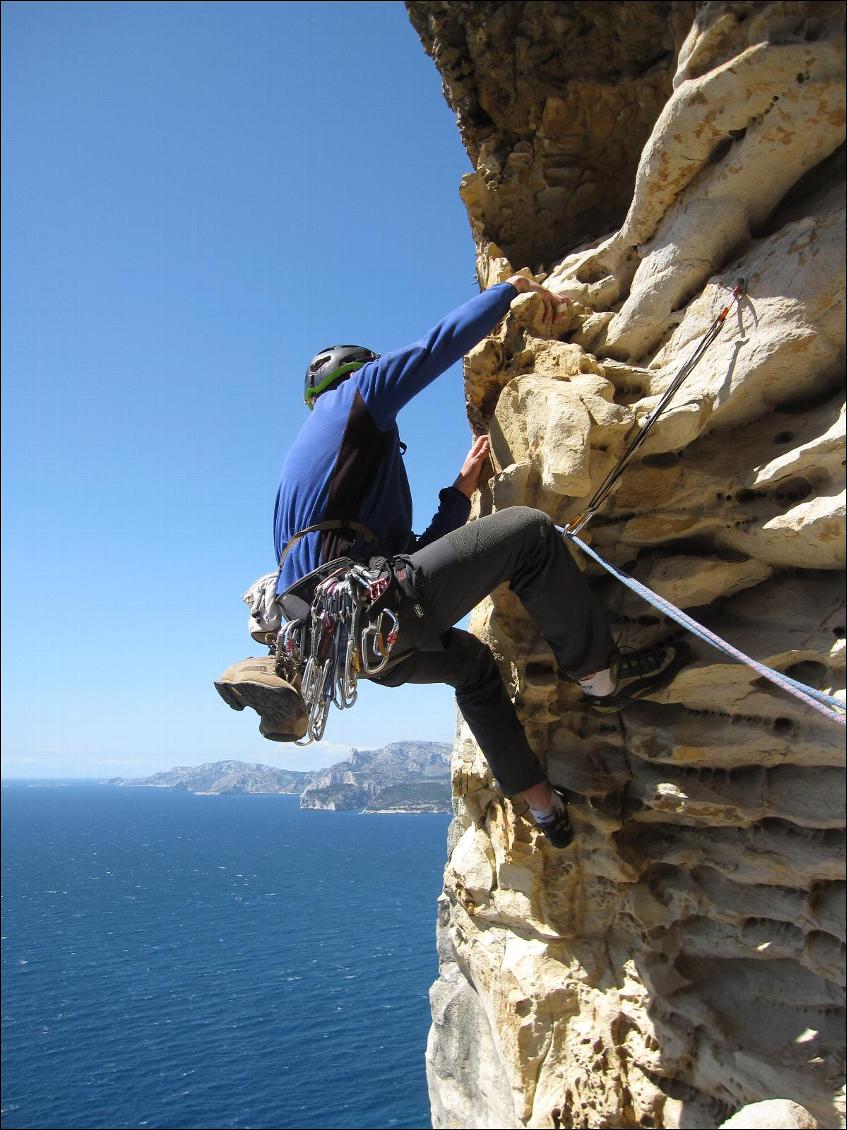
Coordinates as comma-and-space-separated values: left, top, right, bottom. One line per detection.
276, 565, 400, 746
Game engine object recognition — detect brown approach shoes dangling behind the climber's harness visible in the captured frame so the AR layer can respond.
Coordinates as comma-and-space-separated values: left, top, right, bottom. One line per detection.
215, 655, 308, 741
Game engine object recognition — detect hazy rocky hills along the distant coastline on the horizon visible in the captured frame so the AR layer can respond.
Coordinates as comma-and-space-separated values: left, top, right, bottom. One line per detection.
113, 741, 452, 812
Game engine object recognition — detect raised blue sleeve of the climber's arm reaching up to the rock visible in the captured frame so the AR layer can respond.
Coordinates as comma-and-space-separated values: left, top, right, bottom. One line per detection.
353, 283, 517, 432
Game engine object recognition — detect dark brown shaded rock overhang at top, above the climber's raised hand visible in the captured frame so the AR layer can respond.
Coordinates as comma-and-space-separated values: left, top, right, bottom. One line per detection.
407, 0, 695, 263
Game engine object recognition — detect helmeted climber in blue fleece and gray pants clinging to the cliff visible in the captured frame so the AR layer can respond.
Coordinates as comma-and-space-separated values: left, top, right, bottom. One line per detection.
218, 275, 686, 848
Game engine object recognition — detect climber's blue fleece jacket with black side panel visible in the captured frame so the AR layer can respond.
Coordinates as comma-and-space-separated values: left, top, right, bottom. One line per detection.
273, 283, 516, 592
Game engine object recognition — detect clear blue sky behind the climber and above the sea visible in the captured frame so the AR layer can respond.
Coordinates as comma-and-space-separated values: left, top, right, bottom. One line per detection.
2, 0, 477, 776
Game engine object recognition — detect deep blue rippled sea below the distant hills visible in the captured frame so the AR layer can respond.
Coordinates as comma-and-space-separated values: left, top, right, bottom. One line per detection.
2, 782, 449, 1130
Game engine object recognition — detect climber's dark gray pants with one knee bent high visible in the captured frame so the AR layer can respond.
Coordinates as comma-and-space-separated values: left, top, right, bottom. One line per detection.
374, 506, 612, 796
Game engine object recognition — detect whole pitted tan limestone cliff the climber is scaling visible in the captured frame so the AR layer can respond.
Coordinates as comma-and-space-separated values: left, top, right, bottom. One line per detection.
408, 0, 845, 1128
